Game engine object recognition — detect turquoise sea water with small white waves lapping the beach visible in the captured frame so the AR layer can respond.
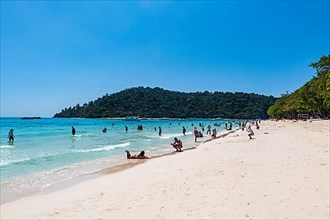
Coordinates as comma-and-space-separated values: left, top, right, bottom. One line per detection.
0, 118, 235, 204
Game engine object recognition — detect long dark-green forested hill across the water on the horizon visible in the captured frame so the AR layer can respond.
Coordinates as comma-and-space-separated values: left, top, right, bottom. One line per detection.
54, 87, 275, 119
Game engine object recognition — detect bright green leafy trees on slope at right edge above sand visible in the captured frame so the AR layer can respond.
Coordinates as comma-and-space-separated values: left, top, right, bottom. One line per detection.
268, 55, 330, 119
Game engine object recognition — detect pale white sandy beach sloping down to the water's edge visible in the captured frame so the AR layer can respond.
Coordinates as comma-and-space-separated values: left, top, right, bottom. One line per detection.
1, 120, 330, 219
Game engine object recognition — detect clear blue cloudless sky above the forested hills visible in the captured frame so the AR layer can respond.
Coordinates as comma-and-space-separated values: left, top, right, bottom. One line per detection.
0, 1, 330, 117
